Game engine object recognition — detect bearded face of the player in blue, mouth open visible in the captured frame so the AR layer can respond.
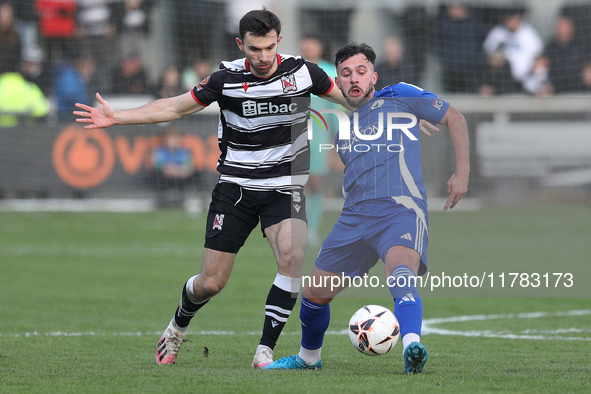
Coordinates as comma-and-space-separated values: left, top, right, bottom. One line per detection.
335, 53, 378, 108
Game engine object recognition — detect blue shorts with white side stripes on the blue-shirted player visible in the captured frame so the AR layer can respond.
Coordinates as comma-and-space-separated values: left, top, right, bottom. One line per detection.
316, 197, 429, 277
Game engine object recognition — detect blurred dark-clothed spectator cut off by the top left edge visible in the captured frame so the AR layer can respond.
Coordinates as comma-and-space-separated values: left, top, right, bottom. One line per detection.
0, 1, 21, 72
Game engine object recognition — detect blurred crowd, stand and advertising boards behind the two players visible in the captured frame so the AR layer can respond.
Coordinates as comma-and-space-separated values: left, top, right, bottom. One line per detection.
0, 0, 591, 211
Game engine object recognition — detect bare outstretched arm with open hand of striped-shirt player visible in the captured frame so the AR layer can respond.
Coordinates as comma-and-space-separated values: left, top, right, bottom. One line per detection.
74, 92, 205, 129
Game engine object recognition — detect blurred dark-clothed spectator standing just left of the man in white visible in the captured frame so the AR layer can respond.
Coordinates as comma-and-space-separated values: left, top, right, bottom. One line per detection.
433, 4, 486, 93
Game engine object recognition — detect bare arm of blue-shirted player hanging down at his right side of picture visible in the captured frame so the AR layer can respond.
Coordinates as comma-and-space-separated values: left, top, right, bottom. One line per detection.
439, 106, 470, 211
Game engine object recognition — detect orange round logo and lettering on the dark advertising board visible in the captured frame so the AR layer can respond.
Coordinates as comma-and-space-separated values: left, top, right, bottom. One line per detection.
51, 124, 220, 189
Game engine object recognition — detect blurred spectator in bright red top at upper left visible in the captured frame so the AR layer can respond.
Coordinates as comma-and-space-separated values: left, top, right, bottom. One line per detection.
35, 0, 78, 64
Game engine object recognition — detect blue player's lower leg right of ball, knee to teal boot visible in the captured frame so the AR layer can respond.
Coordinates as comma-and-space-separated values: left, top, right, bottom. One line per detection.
385, 245, 427, 374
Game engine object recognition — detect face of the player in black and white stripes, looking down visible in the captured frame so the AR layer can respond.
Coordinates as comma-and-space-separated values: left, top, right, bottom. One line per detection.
236, 30, 281, 78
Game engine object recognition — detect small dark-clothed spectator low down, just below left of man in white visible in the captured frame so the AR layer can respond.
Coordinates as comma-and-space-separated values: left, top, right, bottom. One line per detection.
478, 50, 523, 97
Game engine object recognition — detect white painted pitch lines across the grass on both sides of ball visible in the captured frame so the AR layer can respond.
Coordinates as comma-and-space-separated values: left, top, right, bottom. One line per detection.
0, 309, 591, 341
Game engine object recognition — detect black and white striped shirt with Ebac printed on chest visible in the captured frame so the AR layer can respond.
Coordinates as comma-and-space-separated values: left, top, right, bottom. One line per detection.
192, 54, 334, 190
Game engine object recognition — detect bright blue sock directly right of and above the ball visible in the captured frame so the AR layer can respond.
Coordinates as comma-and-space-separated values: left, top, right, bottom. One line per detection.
388, 265, 423, 338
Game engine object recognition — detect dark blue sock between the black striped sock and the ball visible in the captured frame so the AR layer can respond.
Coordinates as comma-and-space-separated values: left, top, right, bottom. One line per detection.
300, 297, 330, 349
